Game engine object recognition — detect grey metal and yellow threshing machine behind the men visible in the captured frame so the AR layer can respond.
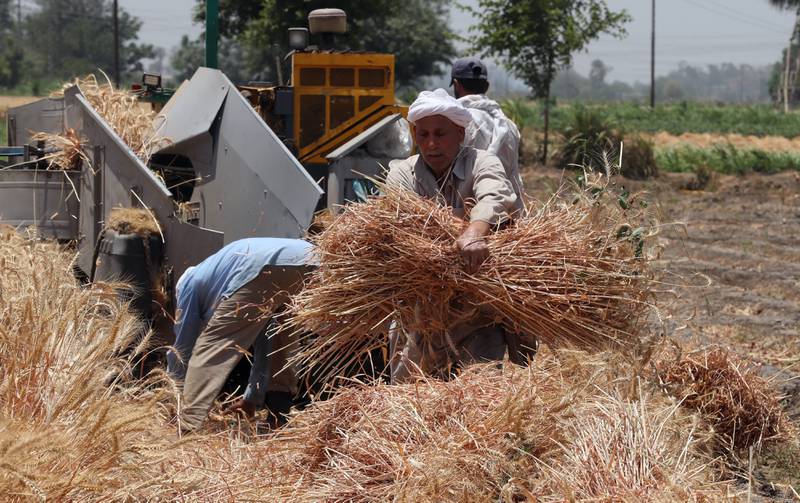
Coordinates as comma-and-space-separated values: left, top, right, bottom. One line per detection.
0, 9, 411, 326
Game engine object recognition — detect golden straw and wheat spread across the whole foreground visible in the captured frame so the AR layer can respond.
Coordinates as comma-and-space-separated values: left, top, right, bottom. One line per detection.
0, 228, 788, 501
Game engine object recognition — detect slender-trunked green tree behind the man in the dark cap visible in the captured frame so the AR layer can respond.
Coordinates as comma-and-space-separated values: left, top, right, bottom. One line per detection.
471, 0, 630, 161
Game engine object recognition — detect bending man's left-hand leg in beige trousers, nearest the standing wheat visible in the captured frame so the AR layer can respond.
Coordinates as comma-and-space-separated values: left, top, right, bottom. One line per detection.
181, 275, 272, 430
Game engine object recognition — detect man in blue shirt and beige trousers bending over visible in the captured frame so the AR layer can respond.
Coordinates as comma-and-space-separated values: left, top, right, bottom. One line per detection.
167, 238, 311, 431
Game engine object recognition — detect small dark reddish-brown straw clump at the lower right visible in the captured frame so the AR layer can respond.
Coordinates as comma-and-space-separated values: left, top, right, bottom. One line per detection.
655, 347, 792, 450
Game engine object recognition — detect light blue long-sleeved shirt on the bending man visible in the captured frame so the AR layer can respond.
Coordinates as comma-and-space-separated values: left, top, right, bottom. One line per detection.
167, 238, 313, 405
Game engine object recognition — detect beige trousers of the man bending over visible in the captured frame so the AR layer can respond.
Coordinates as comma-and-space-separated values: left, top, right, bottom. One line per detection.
180, 266, 305, 430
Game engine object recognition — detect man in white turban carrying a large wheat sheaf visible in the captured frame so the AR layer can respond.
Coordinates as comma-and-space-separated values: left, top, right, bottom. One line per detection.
386, 89, 536, 382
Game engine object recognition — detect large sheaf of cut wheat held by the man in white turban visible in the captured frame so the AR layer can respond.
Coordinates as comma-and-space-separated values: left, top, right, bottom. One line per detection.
290, 181, 651, 382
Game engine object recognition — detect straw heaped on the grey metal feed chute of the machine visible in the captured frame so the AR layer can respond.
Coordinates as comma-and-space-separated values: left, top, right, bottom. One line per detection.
57, 74, 170, 164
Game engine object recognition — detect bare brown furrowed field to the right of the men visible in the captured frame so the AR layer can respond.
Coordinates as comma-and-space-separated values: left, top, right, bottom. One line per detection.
525, 168, 800, 402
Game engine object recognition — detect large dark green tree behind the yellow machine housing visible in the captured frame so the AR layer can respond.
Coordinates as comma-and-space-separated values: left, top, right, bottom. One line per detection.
189, 0, 455, 85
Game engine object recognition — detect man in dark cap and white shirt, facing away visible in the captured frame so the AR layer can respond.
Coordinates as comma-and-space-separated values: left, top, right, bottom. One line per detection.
450, 58, 524, 203
